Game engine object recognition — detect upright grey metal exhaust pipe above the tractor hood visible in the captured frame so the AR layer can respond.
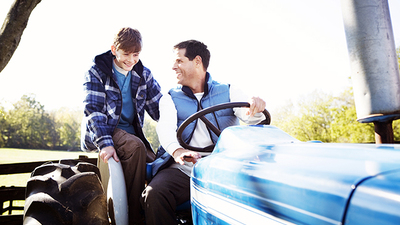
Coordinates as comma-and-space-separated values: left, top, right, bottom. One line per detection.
342, 0, 400, 143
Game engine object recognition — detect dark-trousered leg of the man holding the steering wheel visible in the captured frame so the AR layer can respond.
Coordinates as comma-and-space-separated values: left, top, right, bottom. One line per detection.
142, 168, 190, 225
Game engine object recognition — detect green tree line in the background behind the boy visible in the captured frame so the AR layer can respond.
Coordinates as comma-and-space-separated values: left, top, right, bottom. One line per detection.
0, 95, 160, 150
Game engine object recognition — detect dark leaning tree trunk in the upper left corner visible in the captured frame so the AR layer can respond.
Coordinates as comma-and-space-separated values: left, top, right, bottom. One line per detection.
0, 0, 41, 72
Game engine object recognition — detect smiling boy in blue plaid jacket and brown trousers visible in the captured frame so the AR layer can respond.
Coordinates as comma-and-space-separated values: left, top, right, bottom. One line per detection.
81, 27, 162, 224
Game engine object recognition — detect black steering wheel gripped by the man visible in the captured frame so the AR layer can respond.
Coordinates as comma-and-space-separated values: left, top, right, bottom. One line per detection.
176, 102, 271, 152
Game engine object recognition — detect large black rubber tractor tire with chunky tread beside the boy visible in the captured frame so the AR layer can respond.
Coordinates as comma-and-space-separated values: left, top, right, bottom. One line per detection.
23, 160, 109, 225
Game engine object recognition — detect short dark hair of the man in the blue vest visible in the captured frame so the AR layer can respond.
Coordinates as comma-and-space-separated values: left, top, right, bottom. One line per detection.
174, 40, 211, 71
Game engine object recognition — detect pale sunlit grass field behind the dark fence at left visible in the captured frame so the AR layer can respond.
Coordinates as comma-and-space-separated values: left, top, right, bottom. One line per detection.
0, 148, 97, 187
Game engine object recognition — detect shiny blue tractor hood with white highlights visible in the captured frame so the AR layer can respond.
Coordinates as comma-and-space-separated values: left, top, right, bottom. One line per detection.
191, 126, 400, 224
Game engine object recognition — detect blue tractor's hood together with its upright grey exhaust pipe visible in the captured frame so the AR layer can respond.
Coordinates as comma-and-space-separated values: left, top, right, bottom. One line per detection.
187, 0, 400, 225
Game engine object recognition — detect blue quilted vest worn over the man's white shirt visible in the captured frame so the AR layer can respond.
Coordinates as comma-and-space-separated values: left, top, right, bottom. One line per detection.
168, 73, 239, 147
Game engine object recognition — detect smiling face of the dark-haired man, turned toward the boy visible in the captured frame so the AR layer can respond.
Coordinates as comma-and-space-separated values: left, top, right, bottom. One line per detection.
172, 49, 195, 86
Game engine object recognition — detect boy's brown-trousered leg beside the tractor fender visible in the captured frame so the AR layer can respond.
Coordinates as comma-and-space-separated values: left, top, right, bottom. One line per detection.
113, 128, 147, 224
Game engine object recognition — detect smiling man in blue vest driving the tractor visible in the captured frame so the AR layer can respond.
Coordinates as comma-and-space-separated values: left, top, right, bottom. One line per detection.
142, 40, 265, 225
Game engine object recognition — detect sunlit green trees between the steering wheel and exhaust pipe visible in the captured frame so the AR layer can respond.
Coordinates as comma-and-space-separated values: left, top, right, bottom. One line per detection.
273, 88, 375, 143
